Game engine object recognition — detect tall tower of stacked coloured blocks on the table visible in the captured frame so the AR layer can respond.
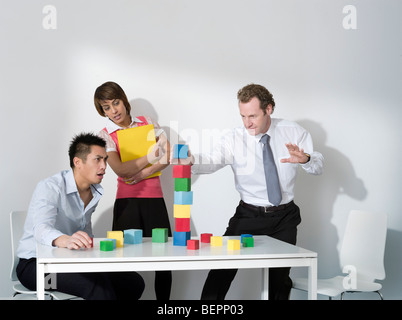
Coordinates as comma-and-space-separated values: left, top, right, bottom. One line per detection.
173, 144, 193, 246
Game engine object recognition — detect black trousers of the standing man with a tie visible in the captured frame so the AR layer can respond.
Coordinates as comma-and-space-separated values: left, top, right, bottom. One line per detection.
201, 201, 301, 300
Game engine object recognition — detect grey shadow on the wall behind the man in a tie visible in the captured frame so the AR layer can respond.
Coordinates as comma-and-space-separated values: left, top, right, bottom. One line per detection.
295, 120, 367, 277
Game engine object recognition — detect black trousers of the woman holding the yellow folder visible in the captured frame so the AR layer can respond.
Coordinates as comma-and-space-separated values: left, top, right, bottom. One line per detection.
113, 198, 172, 300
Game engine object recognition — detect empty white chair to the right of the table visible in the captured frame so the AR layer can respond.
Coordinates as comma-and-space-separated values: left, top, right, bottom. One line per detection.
293, 210, 387, 300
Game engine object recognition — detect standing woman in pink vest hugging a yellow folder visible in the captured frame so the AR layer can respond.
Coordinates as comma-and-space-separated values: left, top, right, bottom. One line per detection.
94, 82, 172, 300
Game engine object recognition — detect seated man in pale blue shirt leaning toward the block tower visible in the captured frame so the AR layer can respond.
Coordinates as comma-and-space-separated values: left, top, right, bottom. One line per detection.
16, 134, 145, 300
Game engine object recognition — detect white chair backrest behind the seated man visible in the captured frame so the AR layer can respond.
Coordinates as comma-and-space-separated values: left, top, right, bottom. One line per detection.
10, 211, 27, 281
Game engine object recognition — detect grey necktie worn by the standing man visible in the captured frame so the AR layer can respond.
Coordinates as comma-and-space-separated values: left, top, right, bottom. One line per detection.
260, 134, 282, 206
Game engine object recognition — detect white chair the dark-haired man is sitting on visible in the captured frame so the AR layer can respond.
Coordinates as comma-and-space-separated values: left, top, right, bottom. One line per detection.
10, 211, 78, 300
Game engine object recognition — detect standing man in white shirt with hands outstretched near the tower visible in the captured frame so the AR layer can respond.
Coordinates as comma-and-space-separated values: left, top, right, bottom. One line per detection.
191, 84, 323, 300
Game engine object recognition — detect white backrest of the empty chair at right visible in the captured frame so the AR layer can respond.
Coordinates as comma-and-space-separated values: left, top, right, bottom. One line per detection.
340, 210, 387, 281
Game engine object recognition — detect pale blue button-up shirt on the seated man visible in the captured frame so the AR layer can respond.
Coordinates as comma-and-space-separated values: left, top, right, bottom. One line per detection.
17, 169, 103, 259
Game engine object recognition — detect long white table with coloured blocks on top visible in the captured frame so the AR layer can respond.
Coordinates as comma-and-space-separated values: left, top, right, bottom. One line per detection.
37, 236, 317, 300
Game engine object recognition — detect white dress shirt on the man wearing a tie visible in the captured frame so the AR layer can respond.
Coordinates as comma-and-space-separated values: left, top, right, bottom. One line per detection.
191, 118, 324, 206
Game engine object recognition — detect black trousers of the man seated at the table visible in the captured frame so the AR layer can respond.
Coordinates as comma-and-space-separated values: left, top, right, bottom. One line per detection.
16, 258, 145, 300
